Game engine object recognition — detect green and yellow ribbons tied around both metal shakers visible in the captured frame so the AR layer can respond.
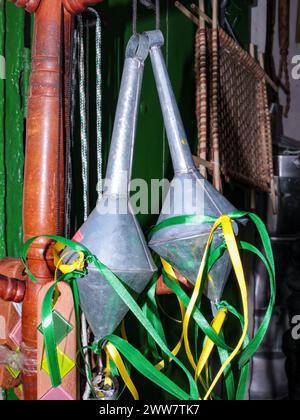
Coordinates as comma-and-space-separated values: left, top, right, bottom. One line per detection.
22, 212, 275, 400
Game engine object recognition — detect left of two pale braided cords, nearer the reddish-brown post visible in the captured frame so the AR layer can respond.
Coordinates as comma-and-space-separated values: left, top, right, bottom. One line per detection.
77, 15, 89, 220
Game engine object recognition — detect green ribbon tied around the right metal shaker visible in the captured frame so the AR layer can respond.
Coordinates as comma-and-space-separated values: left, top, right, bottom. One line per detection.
150, 211, 276, 400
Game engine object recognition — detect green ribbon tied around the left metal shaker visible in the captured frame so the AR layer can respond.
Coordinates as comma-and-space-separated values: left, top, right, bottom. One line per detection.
22, 235, 198, 400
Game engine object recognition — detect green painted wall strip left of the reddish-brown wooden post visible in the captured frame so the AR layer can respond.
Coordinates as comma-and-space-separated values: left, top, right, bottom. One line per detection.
0, 1, 30, 257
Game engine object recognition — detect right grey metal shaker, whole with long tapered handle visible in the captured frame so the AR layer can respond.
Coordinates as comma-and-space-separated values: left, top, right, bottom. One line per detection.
146, 31, 237, 302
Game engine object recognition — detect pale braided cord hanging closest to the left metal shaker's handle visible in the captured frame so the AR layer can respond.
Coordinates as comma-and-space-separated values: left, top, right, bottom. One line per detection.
88, 7, 103, 197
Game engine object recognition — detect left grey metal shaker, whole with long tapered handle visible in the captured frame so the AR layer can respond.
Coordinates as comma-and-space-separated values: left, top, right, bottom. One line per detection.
66, 35, 156, 340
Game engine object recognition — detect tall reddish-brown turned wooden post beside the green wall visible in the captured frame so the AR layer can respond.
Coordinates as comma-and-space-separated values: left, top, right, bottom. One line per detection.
9, 0, 102, 400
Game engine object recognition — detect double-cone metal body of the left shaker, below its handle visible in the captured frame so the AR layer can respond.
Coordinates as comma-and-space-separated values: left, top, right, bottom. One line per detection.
77, 197, 156, 340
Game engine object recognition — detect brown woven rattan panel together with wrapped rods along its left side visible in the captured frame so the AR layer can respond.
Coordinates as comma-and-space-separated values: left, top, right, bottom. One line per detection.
196, 28, 274, 193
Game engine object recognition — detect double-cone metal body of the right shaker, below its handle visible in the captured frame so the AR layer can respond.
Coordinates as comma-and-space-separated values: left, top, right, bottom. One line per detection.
149, 169, 234, 302
